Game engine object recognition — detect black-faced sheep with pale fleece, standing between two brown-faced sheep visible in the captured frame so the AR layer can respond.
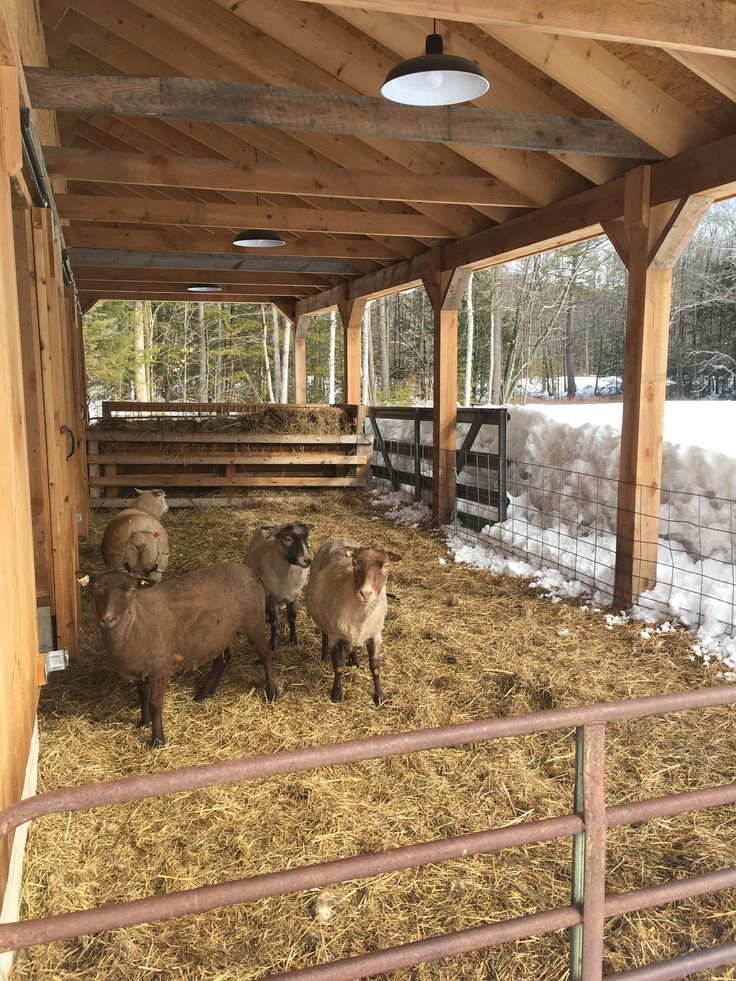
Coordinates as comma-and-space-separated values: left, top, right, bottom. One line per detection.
243, 523, 314, 651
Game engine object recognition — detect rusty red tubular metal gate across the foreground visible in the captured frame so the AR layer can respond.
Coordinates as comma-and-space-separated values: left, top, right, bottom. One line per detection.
0, 685, 736, 981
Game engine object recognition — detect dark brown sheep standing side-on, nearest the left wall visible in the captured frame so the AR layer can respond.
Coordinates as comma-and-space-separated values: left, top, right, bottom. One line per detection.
79, 562, 278, 747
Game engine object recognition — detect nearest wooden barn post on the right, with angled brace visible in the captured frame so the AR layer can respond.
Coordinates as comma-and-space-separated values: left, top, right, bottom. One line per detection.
603, 166, 712, 607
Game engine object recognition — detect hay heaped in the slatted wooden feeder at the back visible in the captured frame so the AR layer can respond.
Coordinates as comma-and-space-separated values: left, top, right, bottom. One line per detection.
90, 403, 351, 439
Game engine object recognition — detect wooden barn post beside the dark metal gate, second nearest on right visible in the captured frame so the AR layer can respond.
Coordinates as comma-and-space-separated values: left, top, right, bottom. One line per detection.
423, 248, 470, 523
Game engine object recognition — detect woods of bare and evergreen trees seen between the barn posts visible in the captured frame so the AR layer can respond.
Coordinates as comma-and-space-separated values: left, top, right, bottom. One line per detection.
84, 202, 736, 405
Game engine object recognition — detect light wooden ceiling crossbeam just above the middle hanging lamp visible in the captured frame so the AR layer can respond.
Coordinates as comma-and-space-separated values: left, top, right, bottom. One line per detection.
56, 194, 454, 238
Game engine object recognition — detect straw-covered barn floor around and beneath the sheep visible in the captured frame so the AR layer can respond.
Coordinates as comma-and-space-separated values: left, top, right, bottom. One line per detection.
14, 492, 736, 981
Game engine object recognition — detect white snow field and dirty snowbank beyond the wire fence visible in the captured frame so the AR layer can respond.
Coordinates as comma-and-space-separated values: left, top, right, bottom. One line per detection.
370, 401, 736, 672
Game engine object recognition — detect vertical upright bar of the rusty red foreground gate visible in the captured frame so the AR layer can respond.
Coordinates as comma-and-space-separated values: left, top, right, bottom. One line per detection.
570, 722, 606, 981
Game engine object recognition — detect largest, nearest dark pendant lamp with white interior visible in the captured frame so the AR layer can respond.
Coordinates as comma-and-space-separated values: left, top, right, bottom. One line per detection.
381, 20, 490, 106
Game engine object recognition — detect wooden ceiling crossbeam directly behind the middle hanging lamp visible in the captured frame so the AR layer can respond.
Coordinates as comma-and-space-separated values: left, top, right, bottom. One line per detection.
64, 224, 402, 260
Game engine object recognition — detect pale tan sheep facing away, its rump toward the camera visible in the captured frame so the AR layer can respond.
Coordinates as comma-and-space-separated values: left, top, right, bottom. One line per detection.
100, 488, 169, 583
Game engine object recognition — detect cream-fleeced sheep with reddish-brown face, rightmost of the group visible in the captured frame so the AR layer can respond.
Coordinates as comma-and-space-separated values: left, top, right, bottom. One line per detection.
304, 538, 401, 705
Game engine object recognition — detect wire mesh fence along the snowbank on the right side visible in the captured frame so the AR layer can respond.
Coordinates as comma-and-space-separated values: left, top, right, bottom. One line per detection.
373, 433, 736, 638
